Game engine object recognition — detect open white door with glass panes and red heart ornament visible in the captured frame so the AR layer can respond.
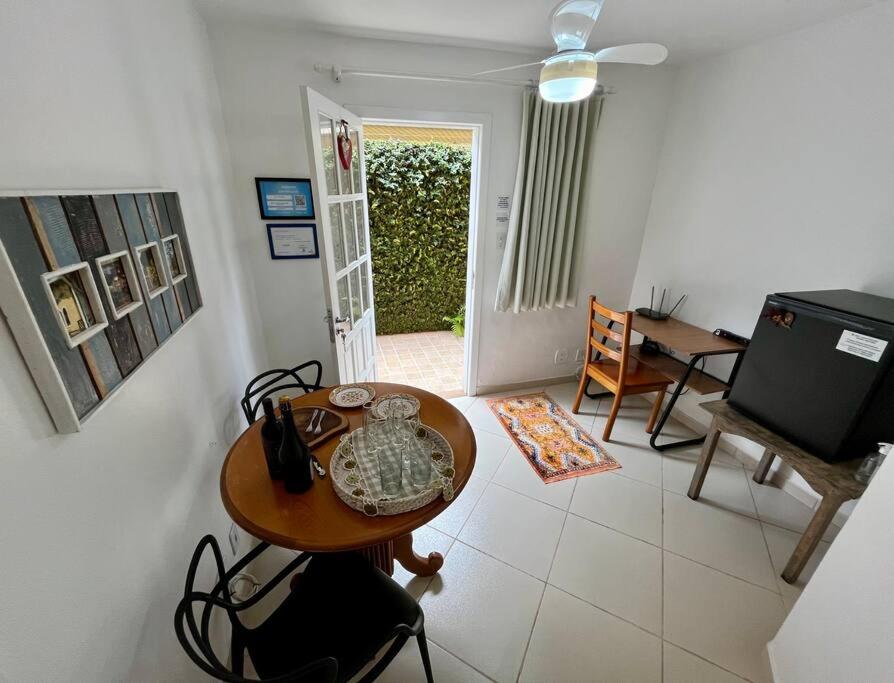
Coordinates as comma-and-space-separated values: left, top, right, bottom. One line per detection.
301, 86, 376, 384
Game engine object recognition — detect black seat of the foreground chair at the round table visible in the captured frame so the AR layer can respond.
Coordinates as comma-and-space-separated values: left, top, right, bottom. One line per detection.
246, 553, 422, 680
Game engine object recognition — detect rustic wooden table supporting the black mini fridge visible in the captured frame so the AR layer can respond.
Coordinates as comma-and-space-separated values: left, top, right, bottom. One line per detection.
689, 400, 866, 583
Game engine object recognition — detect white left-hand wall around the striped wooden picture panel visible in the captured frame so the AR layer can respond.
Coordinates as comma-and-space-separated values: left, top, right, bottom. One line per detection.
0, 0, 265, 681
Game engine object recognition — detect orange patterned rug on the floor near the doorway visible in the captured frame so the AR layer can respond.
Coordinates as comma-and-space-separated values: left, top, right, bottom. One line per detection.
487, 392, 621, 484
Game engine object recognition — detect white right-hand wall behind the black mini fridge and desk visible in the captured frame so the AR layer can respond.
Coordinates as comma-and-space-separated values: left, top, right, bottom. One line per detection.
630, 3, 894, 496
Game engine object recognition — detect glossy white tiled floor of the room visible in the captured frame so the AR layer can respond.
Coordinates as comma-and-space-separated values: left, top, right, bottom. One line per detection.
383, 384, 848, 683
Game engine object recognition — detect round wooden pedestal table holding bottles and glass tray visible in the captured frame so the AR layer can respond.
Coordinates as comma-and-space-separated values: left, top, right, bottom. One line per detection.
220, 382, 476, 576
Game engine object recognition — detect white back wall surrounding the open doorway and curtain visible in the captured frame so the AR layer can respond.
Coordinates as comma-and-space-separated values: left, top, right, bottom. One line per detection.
203, 17, 672, 387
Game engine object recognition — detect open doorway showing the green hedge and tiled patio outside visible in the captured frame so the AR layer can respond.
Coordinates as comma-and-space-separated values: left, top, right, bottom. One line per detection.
363, 119, 480, 398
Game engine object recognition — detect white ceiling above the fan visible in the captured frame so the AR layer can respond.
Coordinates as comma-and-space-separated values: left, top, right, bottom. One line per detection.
196, 0, 882, 63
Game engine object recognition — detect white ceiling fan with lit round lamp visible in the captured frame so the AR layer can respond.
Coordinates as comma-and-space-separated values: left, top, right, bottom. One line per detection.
475, 0, 667, 102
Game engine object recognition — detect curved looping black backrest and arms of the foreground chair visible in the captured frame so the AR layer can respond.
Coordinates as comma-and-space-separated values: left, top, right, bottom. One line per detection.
174, 534, 338, 683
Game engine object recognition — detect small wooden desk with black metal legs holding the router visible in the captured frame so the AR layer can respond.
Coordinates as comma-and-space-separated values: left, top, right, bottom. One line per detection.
587, 313, 748, 451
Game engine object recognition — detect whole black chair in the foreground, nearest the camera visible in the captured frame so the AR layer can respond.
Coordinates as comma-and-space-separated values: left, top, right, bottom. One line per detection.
174, 535, 432, 683
